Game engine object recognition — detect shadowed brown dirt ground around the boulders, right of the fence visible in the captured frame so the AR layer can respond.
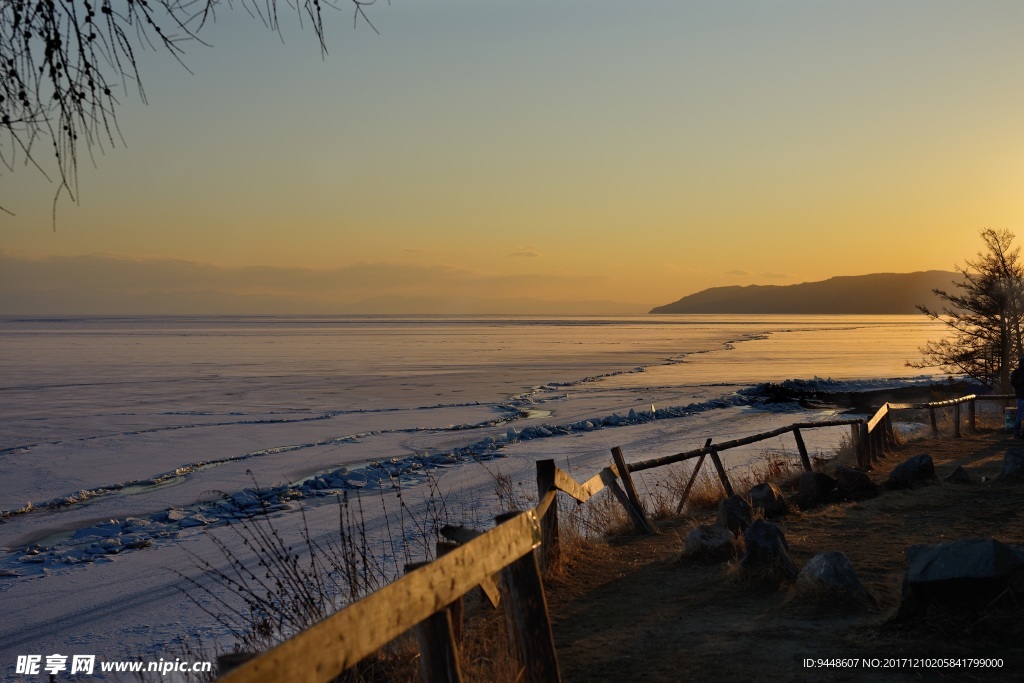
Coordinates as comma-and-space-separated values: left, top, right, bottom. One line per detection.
549, 431, 1024, 681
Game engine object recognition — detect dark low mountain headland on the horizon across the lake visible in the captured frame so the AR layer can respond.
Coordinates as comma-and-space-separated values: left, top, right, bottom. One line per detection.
650, 270, 958, 314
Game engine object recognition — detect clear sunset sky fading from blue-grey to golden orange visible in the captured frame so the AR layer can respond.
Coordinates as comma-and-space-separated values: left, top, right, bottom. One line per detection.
0, 0, 1024, 312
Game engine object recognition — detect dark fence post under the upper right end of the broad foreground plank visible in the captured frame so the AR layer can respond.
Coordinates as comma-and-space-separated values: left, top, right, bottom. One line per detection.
495, 512, 561, 683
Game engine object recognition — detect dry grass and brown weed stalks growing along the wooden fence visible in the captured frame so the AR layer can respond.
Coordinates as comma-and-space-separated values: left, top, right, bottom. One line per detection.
196, 421, 901, 683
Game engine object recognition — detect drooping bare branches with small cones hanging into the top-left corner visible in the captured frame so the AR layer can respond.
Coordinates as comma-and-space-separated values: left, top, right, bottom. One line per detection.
0, 0, 376, 213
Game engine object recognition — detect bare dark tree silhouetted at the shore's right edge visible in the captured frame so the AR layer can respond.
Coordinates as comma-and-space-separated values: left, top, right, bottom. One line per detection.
907, 228, 1024, 392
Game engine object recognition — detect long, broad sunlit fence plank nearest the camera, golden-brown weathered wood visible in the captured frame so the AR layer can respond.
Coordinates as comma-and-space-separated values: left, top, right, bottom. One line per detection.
220, 510, 541, 683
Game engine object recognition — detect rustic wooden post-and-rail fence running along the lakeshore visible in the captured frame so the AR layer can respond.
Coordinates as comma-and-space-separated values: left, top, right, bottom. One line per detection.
218, 394, 1013, 683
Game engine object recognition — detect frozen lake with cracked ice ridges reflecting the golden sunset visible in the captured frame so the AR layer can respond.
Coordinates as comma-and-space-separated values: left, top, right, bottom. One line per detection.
0, 315, 944, 675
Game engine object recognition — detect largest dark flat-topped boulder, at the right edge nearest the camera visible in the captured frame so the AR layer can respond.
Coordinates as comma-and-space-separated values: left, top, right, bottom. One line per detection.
900, 539, 1024, 615
